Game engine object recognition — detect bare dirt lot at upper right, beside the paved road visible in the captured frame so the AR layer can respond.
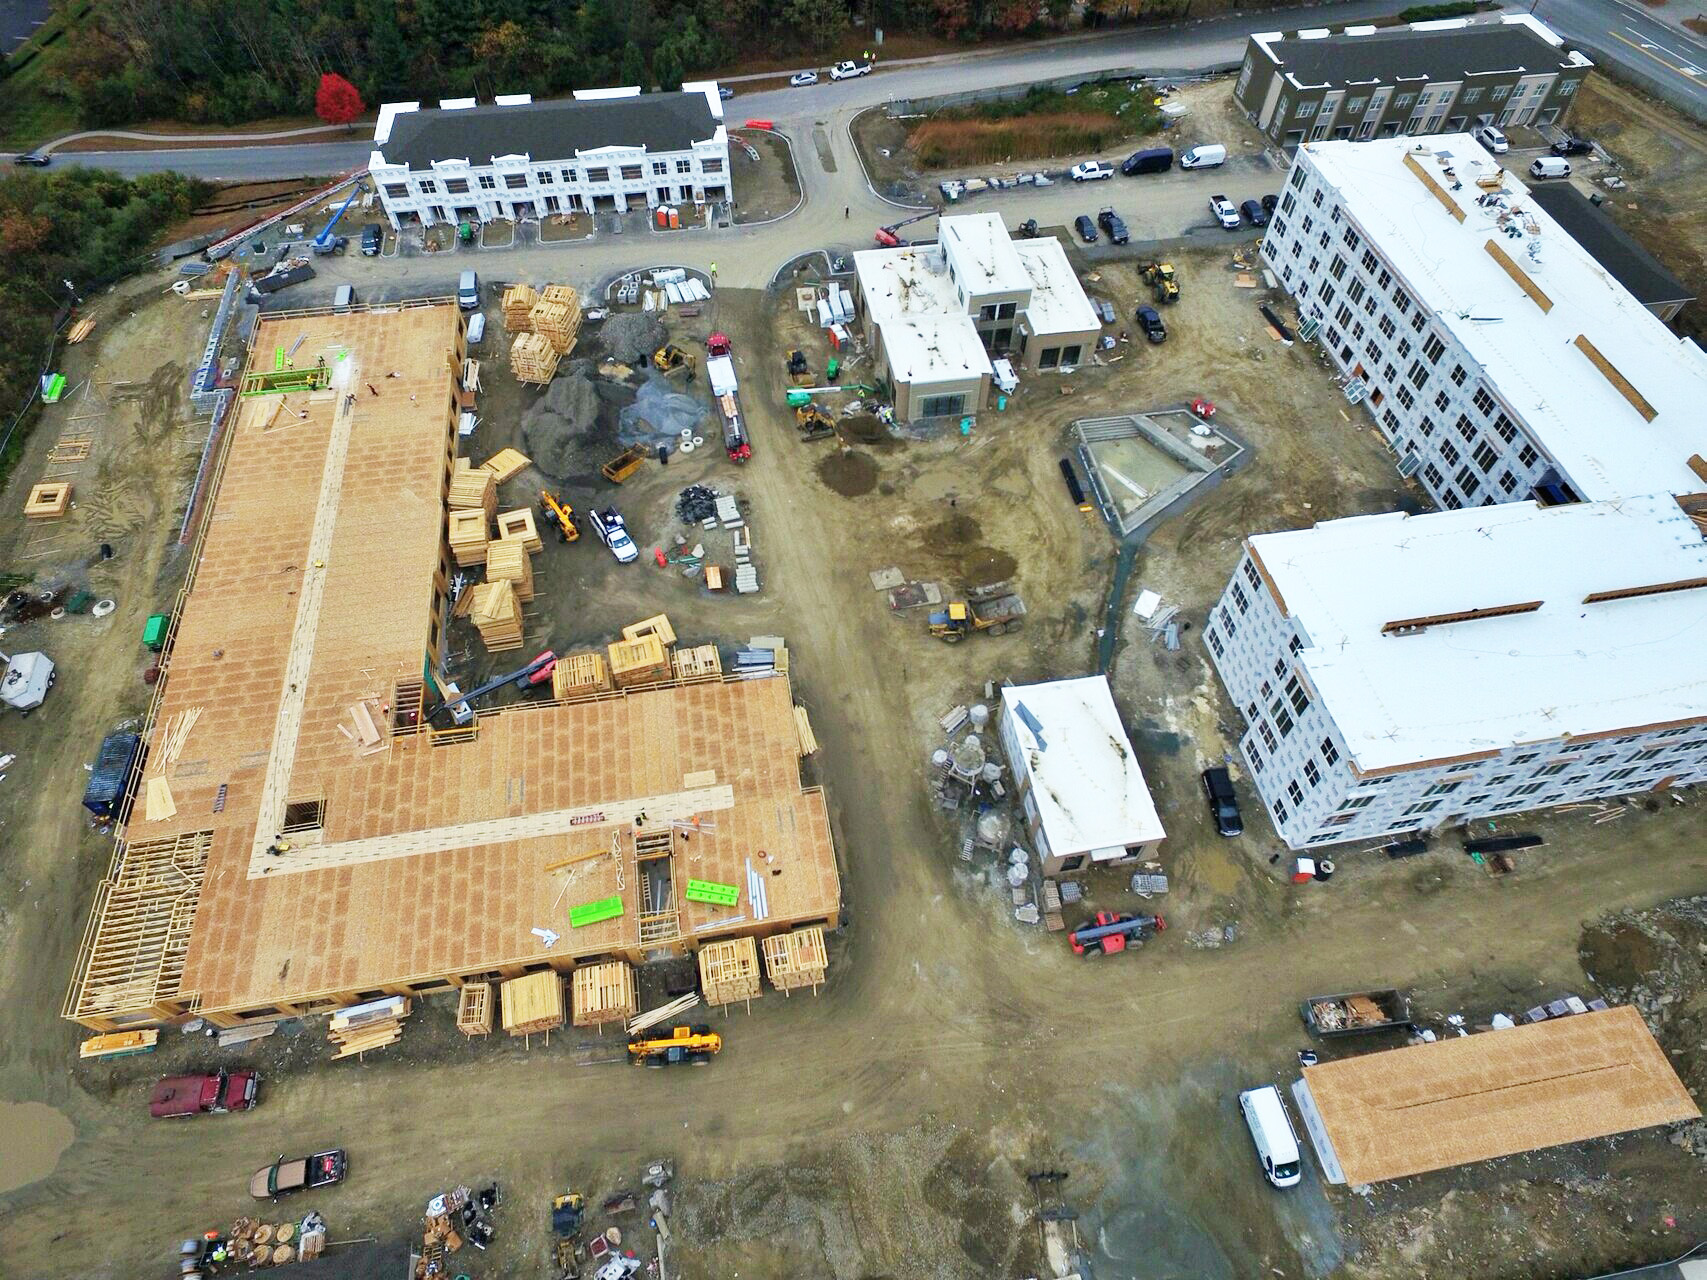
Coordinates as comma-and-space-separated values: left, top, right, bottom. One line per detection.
1570, 75, 1707, 341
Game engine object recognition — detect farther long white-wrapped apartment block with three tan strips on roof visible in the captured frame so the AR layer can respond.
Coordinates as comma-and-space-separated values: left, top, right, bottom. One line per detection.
1261, 133, 1707, 509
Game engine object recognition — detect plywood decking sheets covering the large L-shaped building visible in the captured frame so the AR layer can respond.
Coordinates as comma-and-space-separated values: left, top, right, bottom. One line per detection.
73, 305, 840, 1012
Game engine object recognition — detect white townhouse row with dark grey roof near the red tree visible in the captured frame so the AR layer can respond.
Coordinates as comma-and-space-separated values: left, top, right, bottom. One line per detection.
367, 80, 731, 227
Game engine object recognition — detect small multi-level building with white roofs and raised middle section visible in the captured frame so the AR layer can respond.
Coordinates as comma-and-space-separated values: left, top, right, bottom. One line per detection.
854, 213, 1103, 422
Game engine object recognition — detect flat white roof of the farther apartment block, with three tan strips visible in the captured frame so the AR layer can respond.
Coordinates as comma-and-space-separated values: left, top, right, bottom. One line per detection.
1301, 133, 1707, 500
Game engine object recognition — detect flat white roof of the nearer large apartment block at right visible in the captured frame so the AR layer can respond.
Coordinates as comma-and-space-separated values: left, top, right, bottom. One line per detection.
1250, 495, 1707, 771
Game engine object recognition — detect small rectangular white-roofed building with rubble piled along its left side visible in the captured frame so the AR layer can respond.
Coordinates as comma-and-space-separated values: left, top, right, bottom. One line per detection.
997, 676, 1168, 876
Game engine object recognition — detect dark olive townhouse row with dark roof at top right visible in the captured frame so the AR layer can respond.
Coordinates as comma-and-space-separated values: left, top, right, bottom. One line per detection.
1232, 14, 1593, 147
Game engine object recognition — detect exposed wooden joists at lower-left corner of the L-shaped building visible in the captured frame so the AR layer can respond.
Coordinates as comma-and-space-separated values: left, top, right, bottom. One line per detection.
65, 831, 213, 1019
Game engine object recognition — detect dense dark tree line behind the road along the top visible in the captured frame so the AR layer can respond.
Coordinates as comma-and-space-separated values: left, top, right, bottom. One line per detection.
43, 0, 1092, 128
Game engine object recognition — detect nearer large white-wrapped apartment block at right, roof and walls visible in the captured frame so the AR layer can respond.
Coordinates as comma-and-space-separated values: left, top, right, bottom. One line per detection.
1203, 498, 1707, 848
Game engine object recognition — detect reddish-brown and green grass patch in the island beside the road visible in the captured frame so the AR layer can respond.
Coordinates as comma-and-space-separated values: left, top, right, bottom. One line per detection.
906, 82, 1161, 169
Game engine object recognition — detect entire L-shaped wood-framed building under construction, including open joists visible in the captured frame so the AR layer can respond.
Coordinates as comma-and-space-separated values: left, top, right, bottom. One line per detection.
63, 302, 840, 1031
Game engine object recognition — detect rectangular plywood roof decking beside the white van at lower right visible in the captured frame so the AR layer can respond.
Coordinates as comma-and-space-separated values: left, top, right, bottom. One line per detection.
1304, 1005, 1700, 1186
